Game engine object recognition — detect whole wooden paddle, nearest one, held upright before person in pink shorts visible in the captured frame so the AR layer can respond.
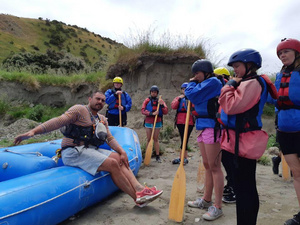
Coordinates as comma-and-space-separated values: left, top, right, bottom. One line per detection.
169, 101, 191, 222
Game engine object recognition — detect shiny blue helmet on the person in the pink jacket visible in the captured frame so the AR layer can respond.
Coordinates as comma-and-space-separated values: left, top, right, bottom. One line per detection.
227, 48, 262, 69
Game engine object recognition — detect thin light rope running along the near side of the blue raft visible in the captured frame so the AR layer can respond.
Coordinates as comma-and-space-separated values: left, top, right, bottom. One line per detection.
0, 157, 138, 220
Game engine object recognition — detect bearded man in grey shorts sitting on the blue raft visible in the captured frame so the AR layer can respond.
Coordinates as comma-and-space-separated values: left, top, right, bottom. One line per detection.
14, 91, 163, 207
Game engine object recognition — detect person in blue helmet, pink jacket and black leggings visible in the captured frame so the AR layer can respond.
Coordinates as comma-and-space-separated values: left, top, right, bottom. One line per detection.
219, 49, 277, 225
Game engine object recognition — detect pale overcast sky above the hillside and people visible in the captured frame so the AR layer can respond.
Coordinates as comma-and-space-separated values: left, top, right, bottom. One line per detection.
0, 0, 300, 75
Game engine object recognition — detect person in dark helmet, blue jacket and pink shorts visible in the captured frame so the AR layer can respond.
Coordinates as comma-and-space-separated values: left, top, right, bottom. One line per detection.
185, 59, 224, 220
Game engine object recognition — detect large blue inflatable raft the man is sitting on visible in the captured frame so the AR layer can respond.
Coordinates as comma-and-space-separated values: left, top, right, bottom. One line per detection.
0, 127, 142, 225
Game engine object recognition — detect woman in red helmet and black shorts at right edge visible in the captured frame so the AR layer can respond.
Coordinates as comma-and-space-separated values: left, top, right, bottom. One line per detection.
275, 38, 300, 225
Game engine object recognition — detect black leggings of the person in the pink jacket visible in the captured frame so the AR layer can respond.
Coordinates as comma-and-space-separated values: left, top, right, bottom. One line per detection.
222, 151, 259, 225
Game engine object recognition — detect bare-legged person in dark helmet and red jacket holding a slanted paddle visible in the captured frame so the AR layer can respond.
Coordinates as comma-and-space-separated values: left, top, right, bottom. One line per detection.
141, 85, 168, 163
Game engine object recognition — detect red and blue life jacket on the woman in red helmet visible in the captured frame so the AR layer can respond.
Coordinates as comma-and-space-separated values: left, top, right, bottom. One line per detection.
276, 68, 300, 110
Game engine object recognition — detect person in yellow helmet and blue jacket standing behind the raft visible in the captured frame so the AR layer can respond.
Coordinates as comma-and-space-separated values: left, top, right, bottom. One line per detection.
105, 77, 132, 127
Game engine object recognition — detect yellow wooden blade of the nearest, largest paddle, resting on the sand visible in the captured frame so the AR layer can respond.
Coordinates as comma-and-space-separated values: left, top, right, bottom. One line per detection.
169, 164, 186, 222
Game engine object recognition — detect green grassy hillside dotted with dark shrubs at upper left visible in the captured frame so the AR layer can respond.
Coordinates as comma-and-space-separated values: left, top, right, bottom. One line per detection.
0, 14, 123, 66
